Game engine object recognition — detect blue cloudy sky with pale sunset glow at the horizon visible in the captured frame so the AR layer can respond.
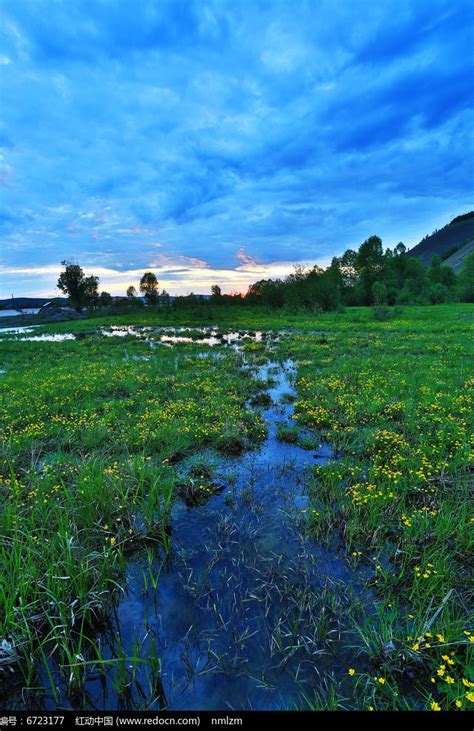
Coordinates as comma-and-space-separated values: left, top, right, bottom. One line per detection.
0, 0, 474, 298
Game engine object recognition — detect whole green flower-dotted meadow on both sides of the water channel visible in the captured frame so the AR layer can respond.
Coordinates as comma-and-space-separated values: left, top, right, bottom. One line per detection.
0, 305, 474, 710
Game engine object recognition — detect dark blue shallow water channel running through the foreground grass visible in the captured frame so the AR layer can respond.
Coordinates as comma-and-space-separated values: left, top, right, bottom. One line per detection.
12, 346, 373, 710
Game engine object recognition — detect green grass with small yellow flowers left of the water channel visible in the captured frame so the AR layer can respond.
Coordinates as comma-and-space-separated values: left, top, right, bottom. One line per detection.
0, 337, 264, 696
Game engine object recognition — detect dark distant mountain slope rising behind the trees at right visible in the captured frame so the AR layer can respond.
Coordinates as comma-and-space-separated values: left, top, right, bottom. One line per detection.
408, 211, 474, 271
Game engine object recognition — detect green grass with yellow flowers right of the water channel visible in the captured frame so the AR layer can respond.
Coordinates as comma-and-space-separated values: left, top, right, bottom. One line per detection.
281, 307, 474, 710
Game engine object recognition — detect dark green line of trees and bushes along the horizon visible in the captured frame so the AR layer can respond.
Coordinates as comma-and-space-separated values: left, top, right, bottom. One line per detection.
58, 236, 474, 311
